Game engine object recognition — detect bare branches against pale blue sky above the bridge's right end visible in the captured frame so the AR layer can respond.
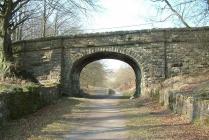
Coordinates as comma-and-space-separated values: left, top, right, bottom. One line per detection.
151, 0, 209, 28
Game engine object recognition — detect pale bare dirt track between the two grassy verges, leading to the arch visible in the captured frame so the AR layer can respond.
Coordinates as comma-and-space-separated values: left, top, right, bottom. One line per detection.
65, 95, 128, 140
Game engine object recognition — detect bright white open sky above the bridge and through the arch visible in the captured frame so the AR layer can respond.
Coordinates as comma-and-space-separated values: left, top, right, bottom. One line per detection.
83, 0, 171, 69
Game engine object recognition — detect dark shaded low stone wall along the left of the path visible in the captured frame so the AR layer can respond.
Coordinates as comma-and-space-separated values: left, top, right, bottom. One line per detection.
0, 87, 60, 128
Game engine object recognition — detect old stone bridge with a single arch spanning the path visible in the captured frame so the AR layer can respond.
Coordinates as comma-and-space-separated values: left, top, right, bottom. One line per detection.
13, 27, 209, 96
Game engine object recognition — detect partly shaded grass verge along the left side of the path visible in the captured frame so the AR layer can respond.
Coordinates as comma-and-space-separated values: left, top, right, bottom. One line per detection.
0, 98, 79, 140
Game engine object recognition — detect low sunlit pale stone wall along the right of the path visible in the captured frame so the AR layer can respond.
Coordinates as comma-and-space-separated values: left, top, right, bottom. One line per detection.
159, 91, 209, 125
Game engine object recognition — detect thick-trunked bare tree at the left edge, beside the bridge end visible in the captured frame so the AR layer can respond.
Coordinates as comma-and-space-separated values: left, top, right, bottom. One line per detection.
0, 0, 32, 75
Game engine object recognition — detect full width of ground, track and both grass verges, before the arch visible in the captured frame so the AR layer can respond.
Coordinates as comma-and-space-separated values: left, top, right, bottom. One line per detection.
0, 92, 209, 140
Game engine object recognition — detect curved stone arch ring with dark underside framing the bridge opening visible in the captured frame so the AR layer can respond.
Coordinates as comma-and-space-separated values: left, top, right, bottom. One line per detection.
69, 49, 142, 96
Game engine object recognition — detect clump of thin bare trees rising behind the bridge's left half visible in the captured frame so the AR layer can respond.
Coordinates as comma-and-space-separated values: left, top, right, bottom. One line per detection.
14, 0, 98, 39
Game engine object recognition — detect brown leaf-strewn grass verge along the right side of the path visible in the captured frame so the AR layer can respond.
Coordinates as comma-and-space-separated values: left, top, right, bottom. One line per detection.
123, 98, 209, 140
